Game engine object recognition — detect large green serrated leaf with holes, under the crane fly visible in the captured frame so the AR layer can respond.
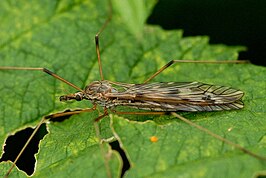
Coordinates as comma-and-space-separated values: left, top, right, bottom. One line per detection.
0, 0, 266, 177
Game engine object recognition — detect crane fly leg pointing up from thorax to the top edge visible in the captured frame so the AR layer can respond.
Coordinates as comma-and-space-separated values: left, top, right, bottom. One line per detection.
95, 0, 113, 80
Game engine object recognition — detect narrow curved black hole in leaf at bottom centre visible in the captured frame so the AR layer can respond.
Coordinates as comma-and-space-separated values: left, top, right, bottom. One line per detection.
109, 141, 130, 177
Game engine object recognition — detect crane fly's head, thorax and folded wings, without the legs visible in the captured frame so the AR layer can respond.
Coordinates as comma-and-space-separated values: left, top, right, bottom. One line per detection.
60, 80, 244, 112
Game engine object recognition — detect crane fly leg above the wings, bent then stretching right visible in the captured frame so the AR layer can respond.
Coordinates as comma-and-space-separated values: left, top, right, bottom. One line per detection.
143, 60, 249, 83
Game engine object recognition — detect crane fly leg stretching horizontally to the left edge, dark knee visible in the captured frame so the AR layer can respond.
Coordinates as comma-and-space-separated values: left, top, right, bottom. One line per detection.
0, 67, 84, 92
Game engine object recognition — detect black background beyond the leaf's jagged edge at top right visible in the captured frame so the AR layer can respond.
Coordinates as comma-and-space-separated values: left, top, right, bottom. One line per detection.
148, 0, 266, 66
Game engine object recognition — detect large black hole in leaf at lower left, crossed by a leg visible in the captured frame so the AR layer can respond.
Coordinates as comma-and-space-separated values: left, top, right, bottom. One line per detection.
0, 123, 48, 175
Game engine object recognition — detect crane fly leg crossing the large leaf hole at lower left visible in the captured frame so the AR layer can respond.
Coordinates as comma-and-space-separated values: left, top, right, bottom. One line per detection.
5, 105, 96, 178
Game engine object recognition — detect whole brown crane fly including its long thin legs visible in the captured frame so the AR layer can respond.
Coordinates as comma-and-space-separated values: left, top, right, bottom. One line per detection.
0, 0, 266, 178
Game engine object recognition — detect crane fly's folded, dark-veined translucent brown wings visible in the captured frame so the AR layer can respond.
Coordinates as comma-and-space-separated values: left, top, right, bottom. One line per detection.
106, 82, 244, 111
